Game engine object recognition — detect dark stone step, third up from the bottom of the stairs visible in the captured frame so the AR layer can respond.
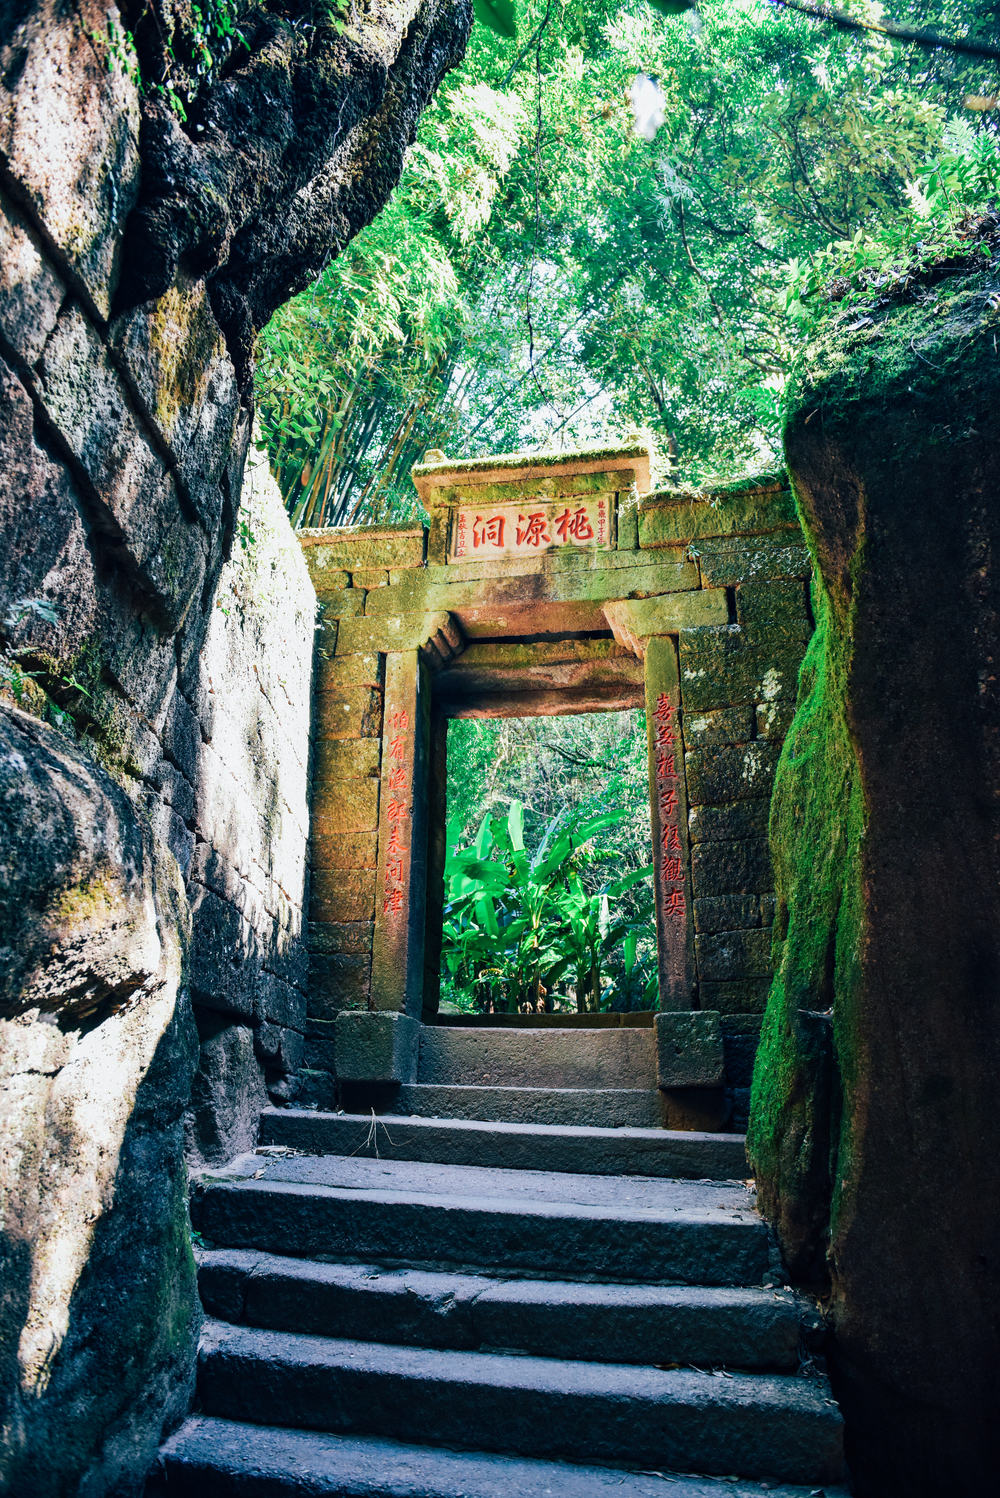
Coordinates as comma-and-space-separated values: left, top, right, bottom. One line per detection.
198, 1249, 819, 1369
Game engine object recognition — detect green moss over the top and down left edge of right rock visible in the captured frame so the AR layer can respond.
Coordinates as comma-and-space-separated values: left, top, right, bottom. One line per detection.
747, 271, 1000, 1276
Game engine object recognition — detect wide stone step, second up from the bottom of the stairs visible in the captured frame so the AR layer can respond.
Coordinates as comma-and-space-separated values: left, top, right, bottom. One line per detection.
199, 1321, 844, 1483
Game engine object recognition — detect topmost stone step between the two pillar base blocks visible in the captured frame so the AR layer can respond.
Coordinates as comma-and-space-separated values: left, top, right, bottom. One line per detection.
416, 1025, 656, 1089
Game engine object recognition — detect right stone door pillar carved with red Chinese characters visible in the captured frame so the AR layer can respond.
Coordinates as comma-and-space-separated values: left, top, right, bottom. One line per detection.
645, 635, 695, 1010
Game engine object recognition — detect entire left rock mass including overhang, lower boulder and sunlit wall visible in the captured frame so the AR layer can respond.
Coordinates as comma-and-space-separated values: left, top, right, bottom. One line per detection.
0, 0, 472, 1498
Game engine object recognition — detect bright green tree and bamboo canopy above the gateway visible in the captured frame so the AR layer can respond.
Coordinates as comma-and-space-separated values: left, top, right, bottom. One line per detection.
257, 0, 1000, 526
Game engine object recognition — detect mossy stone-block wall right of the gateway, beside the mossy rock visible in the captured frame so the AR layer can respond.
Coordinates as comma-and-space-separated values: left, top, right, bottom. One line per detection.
638, 478, 813, 1129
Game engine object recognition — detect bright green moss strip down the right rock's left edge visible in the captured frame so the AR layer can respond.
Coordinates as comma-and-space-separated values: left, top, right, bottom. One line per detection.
747, 556, 865, 1279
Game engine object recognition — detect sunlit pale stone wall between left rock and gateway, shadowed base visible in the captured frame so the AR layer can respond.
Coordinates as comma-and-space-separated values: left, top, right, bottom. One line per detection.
183, 452, 316, 1161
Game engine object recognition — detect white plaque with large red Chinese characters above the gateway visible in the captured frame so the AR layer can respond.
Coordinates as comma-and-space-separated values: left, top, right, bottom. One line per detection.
452, 494, 612, 562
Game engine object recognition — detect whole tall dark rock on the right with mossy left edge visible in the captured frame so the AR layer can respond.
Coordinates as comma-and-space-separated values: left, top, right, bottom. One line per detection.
750, 274, 1000, 1498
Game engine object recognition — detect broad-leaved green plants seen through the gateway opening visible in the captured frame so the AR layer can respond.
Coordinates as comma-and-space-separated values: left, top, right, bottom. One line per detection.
442, 800, 651, 1014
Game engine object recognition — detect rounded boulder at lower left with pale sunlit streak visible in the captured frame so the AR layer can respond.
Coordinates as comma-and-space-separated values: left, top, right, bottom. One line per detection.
0, 706, 201, 1495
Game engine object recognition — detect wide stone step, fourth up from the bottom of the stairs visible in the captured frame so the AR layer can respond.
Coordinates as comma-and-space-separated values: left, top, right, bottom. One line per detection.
192, 1155, 768, 1285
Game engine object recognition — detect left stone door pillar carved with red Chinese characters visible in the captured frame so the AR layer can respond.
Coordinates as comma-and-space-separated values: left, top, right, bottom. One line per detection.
368, 650, 431, 1020
